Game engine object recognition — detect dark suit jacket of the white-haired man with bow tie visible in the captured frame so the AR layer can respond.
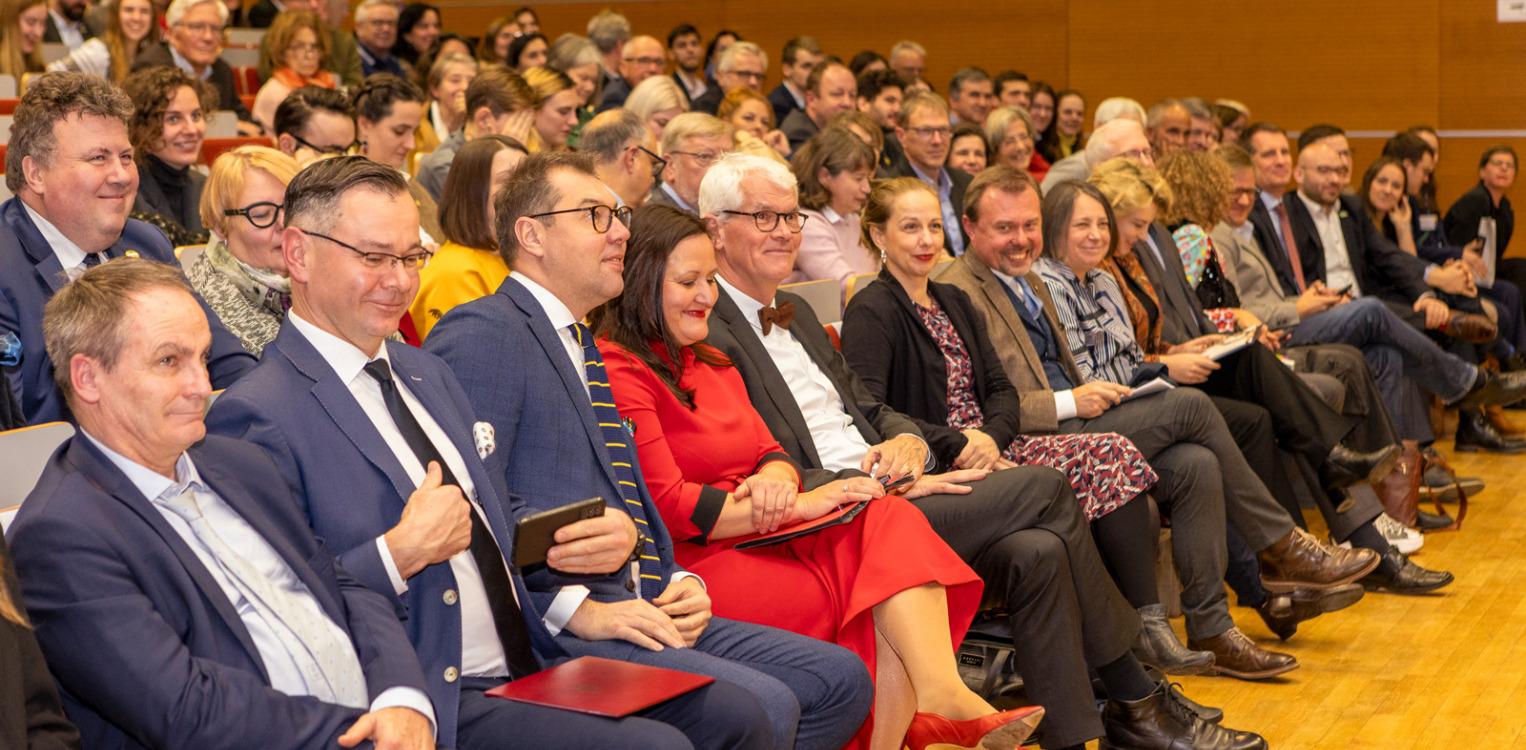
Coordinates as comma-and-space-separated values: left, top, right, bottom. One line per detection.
705, 282, 922, 489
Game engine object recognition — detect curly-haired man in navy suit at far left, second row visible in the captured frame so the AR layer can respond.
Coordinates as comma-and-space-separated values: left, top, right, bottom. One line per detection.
0, 73, 255, 425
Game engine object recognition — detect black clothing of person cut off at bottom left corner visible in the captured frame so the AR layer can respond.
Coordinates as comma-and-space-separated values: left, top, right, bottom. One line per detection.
0, 535, 79, 750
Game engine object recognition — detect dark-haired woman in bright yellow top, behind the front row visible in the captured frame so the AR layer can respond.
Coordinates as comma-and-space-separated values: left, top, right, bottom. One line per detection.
407, 136, 528, 339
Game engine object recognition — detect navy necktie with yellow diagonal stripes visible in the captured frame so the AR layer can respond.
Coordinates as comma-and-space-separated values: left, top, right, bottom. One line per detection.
568, 322, 662, 600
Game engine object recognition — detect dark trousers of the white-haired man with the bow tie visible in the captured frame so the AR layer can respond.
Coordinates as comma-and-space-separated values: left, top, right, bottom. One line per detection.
913, 466, 1140, 747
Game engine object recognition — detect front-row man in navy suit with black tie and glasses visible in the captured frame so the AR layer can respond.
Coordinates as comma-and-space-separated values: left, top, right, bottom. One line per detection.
209, 156, 799, 748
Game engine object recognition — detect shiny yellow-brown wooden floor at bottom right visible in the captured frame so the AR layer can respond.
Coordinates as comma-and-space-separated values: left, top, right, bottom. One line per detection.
1123, 441, 1526, 750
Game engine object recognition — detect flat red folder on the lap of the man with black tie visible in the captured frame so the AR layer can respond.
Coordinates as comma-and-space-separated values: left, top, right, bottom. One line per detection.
487, 657, 716, 718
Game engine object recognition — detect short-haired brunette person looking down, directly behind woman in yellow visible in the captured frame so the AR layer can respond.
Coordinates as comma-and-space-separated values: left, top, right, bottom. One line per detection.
415, 66, 540, 202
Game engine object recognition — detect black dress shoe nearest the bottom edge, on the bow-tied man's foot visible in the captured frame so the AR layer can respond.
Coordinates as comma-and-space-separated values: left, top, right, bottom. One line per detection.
1097, 683, 1267, 750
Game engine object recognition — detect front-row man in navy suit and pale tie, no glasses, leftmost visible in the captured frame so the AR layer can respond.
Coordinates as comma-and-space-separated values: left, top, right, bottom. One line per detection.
9, 260, 435, 750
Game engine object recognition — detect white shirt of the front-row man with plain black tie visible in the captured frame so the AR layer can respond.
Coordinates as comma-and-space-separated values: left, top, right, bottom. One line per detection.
288, 313, 513, 677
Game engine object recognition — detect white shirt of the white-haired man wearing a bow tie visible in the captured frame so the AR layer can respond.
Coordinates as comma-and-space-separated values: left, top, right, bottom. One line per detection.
716, 276, 870, 472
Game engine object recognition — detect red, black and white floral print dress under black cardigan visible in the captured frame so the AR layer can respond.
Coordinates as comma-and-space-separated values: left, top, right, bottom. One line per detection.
913, 302, 1157, 521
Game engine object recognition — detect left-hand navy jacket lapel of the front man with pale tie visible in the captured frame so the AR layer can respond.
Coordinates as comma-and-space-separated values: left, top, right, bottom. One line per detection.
67, 435, 270, 684
